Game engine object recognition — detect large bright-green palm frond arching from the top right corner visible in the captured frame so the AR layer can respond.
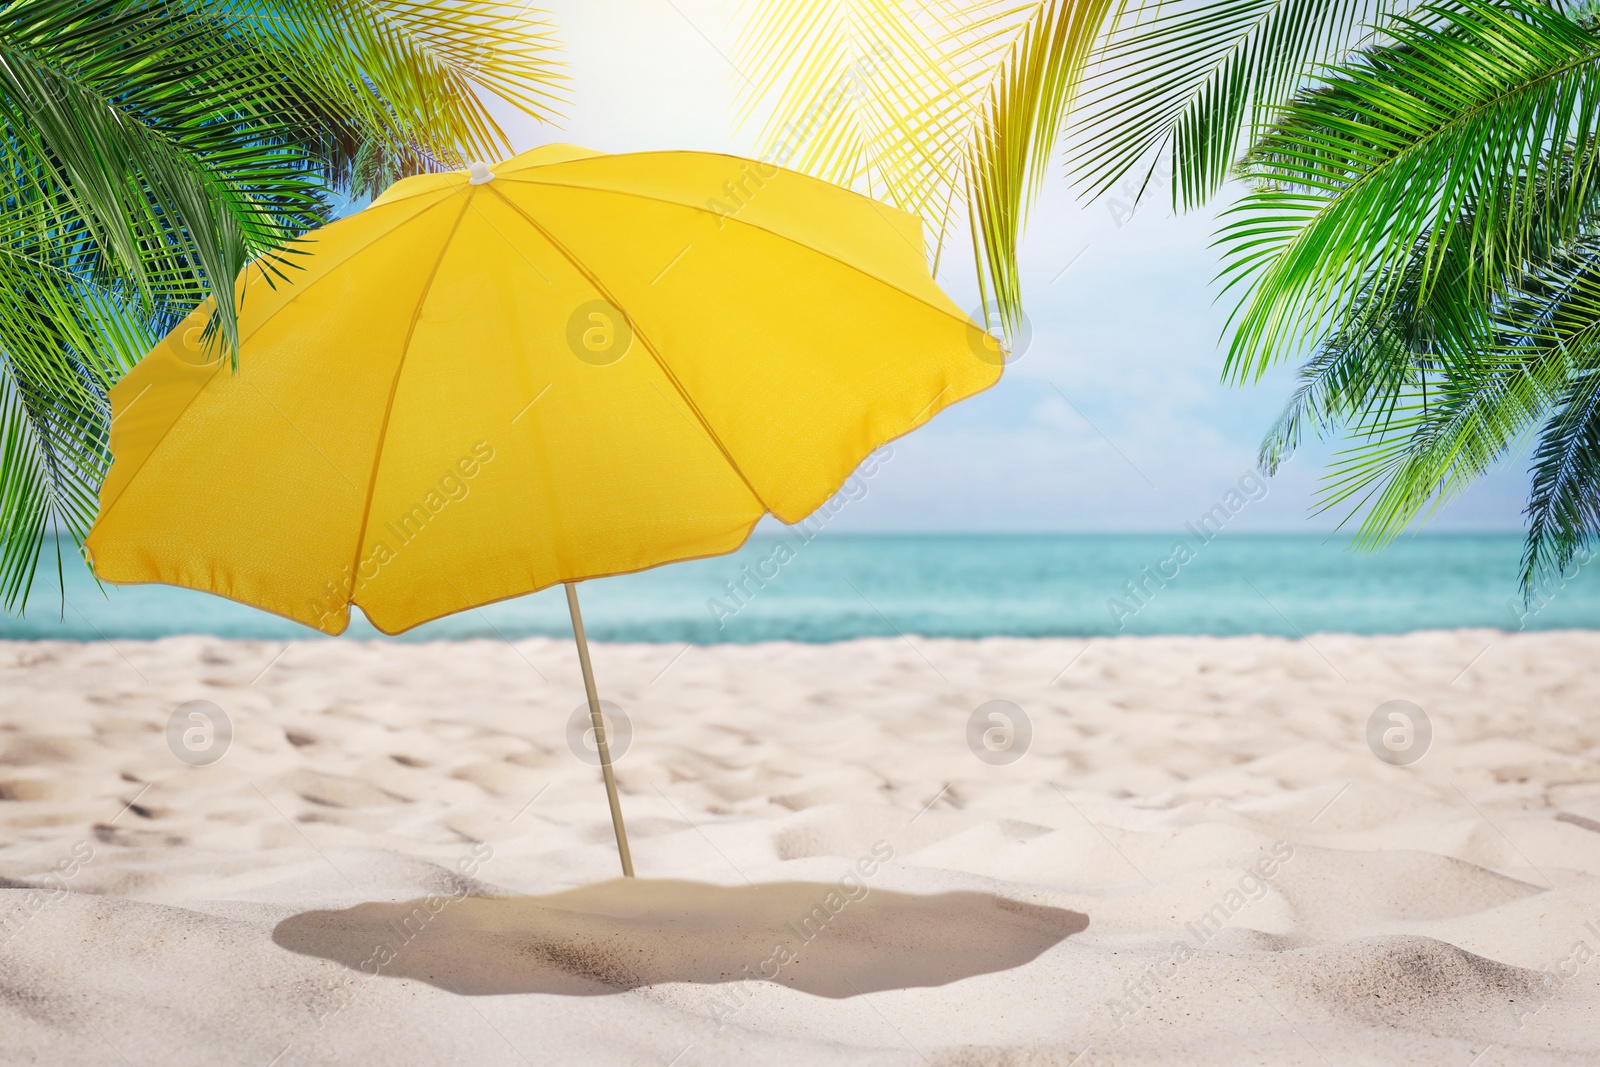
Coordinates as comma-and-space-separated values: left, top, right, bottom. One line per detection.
1219, 0, 1600, 379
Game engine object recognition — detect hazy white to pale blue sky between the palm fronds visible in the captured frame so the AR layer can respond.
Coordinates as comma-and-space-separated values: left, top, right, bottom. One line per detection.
494, 0, 1526, 533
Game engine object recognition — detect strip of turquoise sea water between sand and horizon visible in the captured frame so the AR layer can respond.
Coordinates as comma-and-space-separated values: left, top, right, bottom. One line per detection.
0, 533, 1600, 643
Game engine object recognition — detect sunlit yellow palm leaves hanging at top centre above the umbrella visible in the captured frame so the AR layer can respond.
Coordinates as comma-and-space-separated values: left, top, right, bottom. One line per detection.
736, 0, 1115, 328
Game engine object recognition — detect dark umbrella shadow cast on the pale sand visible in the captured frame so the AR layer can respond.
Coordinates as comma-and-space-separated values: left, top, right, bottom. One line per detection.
272, 878, 1090, 998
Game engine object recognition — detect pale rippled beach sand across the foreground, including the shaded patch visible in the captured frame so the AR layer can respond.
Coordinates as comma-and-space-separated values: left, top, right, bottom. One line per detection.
0, 630, 1600, 1067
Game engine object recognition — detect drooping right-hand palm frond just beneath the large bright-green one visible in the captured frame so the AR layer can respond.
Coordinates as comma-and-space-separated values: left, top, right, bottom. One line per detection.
1262, 223, 1600, 575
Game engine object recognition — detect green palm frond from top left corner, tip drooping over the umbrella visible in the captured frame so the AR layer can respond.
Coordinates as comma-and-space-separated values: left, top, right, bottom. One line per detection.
0, 0, 320, 355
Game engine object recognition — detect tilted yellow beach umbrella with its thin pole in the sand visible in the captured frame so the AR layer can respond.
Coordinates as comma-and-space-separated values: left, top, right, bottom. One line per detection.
88, 146, 1003, 873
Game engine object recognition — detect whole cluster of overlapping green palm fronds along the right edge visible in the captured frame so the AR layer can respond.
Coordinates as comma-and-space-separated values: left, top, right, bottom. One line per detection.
1222, 0, 1600, 592
